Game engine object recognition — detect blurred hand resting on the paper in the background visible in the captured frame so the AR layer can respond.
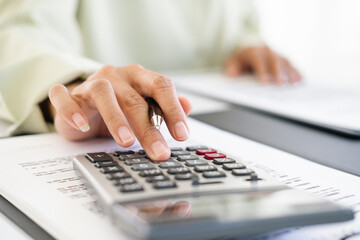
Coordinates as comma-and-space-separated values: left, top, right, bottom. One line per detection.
226, 46, 301, 84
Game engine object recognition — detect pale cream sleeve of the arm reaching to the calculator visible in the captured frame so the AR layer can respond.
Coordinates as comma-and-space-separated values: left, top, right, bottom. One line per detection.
0, 0, 101, 137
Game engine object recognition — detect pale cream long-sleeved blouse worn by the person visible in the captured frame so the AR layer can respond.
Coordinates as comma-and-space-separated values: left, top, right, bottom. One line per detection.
0, 0, 260, 136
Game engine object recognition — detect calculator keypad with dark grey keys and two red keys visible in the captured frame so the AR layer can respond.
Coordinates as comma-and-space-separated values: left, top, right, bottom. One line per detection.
86, 145, 261, 193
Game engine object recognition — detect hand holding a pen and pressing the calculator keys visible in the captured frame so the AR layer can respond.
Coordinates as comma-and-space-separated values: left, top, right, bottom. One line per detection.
49, 64, 191, 160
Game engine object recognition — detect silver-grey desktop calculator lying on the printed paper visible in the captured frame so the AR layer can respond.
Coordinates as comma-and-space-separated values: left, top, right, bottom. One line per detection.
73, 145, 354, 240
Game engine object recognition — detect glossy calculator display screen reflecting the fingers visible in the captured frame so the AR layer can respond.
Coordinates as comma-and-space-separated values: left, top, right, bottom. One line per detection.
124, 189, 329, 224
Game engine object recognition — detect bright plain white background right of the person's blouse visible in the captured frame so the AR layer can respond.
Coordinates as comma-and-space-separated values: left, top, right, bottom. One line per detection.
256, 0, 360, 89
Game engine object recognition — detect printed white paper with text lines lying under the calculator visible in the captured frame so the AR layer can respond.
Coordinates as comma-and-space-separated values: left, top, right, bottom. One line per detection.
0, 119, 360, 240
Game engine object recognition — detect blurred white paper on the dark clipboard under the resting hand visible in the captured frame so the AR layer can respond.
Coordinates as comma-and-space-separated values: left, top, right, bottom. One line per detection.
170, 72, 360, 135
